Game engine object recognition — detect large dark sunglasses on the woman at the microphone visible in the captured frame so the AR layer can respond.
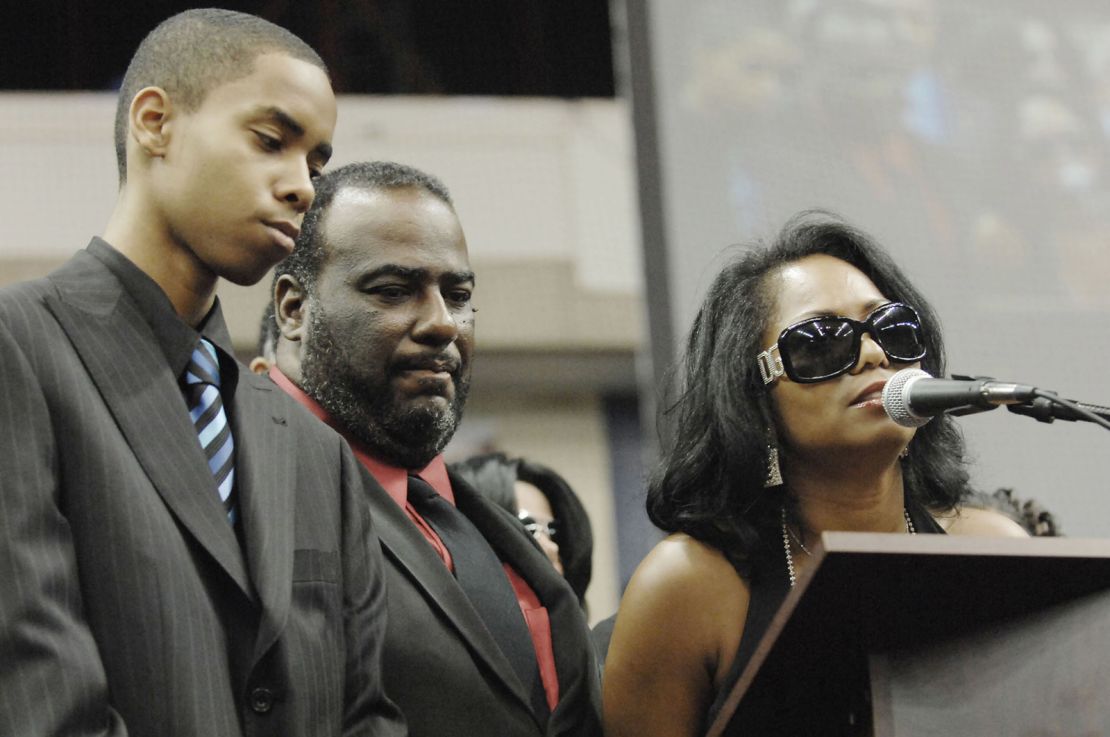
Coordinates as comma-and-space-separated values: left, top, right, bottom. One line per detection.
756, 302, 926, 384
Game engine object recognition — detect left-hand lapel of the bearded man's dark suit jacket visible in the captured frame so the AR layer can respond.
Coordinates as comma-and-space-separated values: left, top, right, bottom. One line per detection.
363, 468, 532, 711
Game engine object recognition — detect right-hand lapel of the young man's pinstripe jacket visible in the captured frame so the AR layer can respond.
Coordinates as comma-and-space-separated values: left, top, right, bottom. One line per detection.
231, 370, 296, 656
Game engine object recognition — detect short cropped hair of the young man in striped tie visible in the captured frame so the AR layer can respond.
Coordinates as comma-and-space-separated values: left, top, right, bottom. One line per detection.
115, 8, 327, 186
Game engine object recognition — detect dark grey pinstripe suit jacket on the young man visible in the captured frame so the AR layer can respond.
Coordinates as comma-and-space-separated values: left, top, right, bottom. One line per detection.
0, 246, 404, 737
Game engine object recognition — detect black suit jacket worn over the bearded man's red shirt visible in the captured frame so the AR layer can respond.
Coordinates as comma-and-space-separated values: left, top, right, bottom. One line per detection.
364, 471, 602, 737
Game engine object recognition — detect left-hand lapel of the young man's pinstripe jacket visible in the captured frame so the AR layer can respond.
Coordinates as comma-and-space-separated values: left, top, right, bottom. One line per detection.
46, 252, 251, 597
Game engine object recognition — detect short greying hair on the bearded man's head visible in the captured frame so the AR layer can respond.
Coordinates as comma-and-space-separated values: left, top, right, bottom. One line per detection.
274, 161, 454, 294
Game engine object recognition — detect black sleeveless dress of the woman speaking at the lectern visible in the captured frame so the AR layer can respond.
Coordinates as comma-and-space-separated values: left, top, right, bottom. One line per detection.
705, 503, 945, 737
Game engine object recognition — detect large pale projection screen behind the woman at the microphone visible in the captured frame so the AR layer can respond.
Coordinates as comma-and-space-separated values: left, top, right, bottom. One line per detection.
627, 0, 1110, 536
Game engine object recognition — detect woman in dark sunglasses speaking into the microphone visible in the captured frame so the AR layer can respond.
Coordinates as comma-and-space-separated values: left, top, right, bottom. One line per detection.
604, 212, 985, 737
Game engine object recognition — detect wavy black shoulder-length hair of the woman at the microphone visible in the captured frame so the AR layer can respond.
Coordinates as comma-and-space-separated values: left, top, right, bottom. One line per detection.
647, 210, 970, 574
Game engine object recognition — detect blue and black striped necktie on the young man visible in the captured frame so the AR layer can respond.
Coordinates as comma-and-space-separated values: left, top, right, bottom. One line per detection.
184, 337, 235, 523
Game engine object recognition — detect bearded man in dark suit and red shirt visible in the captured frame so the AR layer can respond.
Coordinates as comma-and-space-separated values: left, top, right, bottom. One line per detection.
270, 162, 601, 737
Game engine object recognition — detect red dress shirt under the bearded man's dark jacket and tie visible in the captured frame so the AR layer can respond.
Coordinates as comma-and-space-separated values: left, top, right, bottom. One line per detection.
270, 366, 558, 710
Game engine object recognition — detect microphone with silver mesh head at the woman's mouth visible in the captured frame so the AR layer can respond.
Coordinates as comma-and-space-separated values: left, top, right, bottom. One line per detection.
882, 369, 1037, 427
